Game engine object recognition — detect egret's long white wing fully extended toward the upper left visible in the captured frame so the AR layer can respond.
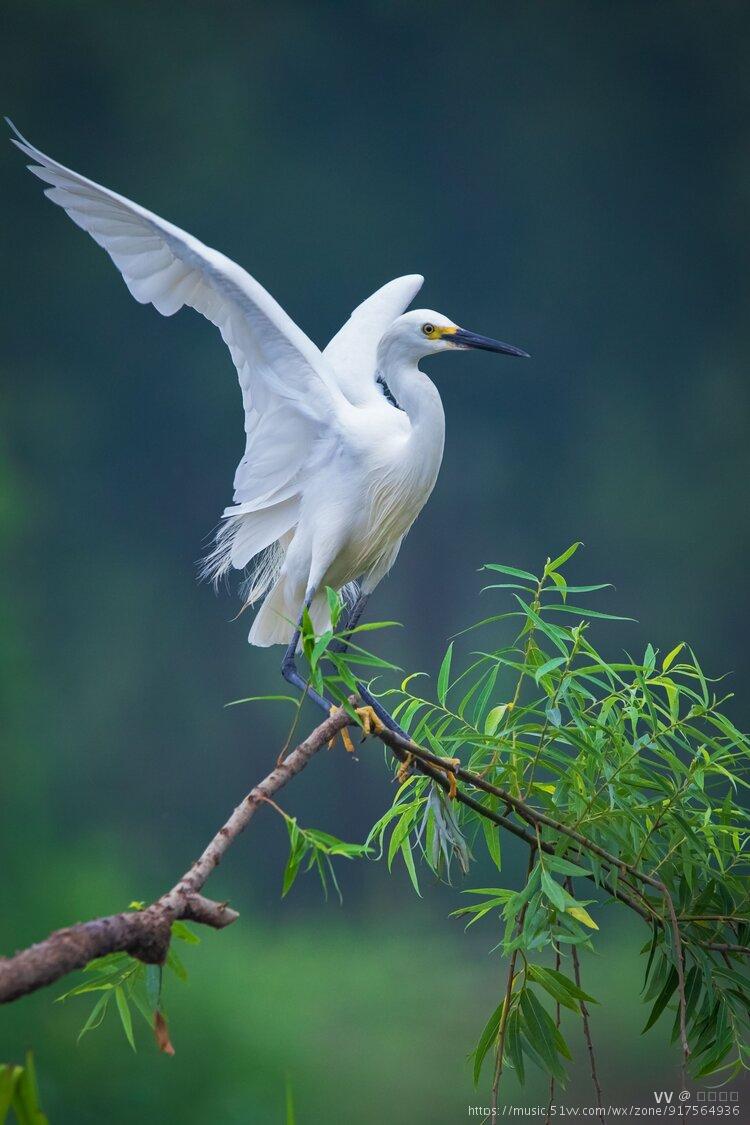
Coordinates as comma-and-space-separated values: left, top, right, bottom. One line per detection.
8, 122, 345, 515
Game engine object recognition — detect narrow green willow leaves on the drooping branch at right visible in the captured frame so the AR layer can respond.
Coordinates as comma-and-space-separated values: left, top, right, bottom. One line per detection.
314, 545, 750, 1082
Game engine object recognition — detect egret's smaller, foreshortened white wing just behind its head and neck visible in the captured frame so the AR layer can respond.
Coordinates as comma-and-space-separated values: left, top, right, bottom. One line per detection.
323, 273, 424, 406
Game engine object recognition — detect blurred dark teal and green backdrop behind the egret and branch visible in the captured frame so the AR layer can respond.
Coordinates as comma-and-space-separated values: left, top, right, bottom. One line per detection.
0, 0, 750, 1125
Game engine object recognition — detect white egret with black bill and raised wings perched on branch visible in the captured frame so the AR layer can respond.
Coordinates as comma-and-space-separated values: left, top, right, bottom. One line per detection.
6, 118, 528, 748
